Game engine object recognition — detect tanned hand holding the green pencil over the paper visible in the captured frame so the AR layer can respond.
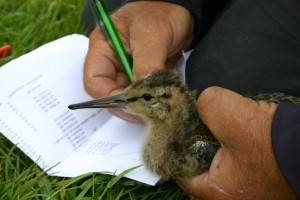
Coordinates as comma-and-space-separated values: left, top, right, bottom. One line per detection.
84, 1, 194, 122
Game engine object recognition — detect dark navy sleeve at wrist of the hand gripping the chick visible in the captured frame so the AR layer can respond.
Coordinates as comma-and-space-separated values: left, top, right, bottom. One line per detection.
272, 102, 300, 197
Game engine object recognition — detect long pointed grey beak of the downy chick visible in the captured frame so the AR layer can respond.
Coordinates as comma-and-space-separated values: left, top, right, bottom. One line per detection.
68, 93, 126, 110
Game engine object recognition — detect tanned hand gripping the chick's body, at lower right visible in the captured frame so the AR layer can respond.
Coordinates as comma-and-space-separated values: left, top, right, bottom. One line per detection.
177, 87, 297, 200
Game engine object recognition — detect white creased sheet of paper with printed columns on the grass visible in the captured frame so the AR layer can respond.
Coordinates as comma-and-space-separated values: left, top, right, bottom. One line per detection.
0, 34, 159, 185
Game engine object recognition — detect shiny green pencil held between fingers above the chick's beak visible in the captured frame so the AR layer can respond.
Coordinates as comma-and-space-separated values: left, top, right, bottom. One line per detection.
94, 0, 133, 83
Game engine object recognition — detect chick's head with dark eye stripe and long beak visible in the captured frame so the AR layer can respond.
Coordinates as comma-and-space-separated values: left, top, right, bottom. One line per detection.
69, 70, 196, 120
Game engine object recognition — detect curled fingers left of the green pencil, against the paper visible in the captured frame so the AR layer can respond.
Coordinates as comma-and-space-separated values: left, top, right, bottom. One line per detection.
84, 28, 128, 98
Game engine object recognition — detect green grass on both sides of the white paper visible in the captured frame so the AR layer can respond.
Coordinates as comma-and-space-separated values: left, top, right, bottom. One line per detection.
0, 0, 187, 200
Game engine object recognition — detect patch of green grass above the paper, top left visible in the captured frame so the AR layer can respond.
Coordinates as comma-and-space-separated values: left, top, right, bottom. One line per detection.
0, 0, 85, 66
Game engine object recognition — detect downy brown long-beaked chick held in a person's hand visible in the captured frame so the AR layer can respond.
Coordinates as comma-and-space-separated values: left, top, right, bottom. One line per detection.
69, 70, 300, 180
